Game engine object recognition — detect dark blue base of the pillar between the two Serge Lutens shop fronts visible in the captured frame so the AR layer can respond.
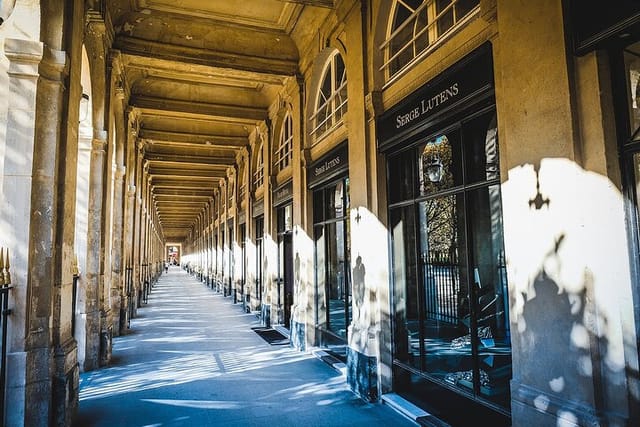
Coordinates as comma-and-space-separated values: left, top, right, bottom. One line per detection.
347, 347, 380, 402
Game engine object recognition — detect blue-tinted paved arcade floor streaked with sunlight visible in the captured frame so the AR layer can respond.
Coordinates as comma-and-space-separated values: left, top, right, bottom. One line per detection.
77, 267, 415, 427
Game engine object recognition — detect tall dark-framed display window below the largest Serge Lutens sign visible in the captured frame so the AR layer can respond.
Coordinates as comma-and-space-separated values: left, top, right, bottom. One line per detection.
388, 106, 511, 413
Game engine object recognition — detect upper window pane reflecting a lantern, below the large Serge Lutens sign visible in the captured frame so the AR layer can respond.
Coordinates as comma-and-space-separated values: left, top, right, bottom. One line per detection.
418, 130, 462, 196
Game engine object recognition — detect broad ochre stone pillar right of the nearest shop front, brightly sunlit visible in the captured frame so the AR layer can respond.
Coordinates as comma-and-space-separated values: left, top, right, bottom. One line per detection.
493, 0, 638, 427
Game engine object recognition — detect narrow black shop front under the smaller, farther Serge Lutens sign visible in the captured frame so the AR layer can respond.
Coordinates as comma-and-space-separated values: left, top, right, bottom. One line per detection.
307, 142, 352, 357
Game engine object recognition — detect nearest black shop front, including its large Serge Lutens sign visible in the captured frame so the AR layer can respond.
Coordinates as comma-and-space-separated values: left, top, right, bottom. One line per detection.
377, 44, 512, 426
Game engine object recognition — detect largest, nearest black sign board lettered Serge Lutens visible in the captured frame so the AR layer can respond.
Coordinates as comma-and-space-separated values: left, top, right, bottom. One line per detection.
378, 45, 493, 148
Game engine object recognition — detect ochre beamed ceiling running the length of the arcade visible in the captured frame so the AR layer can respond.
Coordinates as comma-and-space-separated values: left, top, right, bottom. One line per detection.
105, 0, 333, 242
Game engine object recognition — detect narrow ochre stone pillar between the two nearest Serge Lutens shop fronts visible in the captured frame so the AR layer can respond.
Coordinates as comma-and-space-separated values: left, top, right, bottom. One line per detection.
344, 4, 382, 402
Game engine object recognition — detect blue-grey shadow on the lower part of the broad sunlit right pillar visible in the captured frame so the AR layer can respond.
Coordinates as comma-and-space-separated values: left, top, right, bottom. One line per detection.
514, 235, 625, 425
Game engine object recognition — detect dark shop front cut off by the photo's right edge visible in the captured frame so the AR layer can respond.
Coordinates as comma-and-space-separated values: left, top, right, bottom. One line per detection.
569, 6, 640, 420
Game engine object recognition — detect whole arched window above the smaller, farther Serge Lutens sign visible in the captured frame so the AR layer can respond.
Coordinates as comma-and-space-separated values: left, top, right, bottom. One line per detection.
311, 51, 347, 138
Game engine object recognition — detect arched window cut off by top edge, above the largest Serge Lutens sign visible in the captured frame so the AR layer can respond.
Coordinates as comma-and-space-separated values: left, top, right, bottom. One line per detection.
381, 0, 480, 79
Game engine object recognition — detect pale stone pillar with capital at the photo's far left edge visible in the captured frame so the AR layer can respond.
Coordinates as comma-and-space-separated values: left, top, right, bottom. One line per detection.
0, 39, 43, 426
